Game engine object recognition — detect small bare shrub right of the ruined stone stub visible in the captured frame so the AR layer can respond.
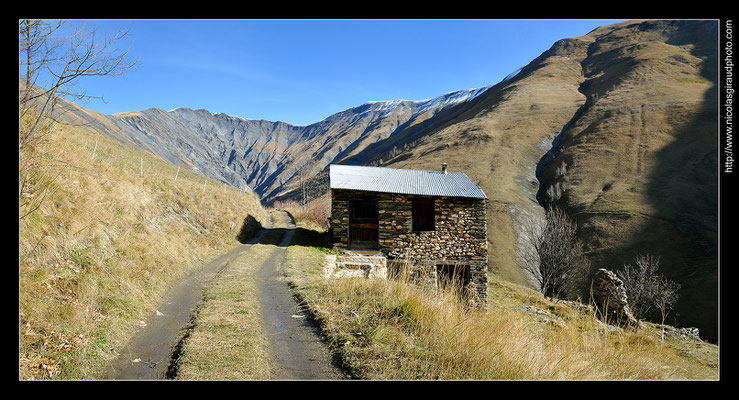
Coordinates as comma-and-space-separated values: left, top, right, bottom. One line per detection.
616, 254, 680, 336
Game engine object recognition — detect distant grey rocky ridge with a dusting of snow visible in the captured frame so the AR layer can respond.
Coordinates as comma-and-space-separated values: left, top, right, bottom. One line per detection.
59, 87, 487, 203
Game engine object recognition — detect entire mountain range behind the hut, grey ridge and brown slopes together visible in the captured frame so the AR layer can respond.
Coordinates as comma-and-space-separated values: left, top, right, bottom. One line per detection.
56, 21, 718, 338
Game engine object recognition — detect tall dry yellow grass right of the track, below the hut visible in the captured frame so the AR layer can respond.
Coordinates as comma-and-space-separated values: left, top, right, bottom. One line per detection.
286, 223, 718, 380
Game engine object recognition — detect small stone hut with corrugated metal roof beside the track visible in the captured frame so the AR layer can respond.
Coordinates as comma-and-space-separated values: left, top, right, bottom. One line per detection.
329, 164, 488, 308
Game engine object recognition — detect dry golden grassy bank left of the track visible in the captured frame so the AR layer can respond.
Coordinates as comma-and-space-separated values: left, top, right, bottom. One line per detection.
18, 118, 266, 379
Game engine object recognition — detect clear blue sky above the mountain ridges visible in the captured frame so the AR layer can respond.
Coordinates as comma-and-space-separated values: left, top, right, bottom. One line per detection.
75, 19, 617, 125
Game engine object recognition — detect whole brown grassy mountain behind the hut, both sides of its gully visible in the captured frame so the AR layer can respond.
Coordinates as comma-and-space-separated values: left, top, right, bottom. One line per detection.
379, 21, 718, 340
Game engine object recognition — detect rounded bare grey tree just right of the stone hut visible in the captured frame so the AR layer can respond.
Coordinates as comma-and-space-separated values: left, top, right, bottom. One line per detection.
520, 206, 590, 298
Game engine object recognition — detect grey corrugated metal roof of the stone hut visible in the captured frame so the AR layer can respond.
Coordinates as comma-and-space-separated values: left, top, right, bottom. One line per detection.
329, 164, 487, 199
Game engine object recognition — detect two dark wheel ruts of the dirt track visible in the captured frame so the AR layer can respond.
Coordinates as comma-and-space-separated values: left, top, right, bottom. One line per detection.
104, 212, 344, 380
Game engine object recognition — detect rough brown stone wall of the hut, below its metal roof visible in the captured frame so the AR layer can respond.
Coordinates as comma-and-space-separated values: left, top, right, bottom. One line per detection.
331, 189, 488, 305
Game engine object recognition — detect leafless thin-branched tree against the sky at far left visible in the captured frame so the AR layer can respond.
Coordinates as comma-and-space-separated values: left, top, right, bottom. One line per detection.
18, 19, 136, 218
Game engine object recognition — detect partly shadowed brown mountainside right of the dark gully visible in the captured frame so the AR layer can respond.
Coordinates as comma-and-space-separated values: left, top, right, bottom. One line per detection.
542, 21, 718, 341
